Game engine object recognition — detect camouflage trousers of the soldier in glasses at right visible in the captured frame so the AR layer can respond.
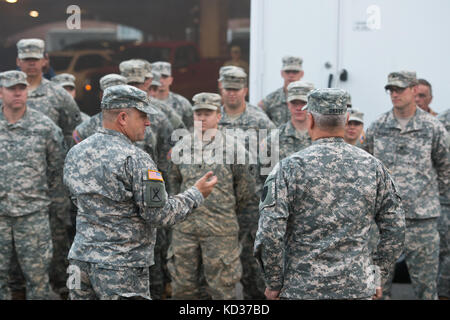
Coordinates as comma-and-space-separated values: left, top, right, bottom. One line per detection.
383, 218, 439, 300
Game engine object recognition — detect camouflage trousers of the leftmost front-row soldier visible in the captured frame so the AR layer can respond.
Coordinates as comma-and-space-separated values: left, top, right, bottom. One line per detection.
0, 211, 52, 300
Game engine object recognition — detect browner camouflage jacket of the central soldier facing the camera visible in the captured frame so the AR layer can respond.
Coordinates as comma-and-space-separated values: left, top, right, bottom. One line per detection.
170, 131, 255, 236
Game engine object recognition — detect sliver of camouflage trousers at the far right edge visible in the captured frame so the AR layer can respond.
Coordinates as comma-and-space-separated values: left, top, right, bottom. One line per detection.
437, 204, 450, 298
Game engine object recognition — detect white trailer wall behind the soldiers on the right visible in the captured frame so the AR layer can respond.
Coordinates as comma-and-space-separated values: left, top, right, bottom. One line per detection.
250, 0, 450, 126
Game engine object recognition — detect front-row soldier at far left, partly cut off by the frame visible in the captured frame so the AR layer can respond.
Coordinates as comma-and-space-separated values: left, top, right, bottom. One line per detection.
0, 71, 66, 300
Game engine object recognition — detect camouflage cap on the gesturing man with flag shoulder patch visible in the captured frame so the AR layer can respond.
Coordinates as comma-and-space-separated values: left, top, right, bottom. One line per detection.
101, 84, 157, 114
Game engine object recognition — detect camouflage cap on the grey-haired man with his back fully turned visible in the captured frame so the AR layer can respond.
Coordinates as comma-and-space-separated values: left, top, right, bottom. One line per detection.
302, 88, 347, 115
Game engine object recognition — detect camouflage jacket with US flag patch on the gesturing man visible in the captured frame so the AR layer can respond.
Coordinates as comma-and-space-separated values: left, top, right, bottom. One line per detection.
64, 128, 203, 267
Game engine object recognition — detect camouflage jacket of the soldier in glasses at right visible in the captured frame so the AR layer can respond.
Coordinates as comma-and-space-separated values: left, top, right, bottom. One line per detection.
363, 108, 450, 219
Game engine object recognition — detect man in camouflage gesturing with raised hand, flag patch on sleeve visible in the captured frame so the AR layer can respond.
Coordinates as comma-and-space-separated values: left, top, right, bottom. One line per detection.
64, 85, 217, 299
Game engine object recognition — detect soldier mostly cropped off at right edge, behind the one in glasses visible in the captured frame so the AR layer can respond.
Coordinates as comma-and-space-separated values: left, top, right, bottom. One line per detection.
437, 109, 450, 299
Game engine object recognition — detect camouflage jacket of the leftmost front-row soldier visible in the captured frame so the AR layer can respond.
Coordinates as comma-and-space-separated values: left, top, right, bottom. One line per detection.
0, 105, 67, 217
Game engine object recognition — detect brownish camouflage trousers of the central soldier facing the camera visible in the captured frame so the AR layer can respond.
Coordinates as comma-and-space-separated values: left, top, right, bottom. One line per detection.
167, 230, 242, 300
